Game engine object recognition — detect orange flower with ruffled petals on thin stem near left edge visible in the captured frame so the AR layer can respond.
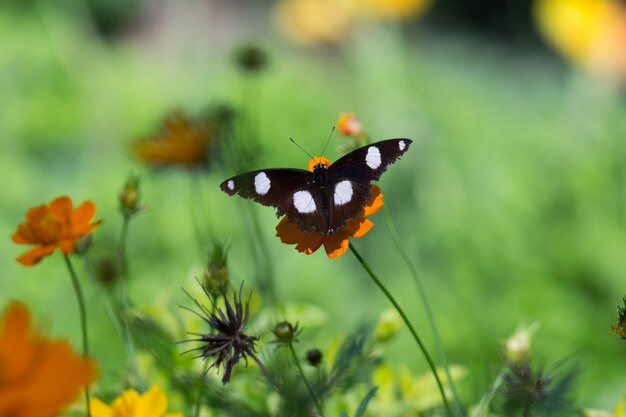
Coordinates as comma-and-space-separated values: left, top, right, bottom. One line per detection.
11, 196, 101, 266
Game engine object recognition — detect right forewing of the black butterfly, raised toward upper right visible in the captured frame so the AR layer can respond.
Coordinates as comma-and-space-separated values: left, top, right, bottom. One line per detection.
328, 138, 413, 181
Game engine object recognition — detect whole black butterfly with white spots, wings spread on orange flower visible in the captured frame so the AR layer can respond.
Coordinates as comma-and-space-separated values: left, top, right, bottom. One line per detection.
220, 139, 412, 235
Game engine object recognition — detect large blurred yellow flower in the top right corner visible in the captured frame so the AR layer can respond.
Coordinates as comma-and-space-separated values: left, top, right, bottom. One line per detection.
535, 0, 626, 76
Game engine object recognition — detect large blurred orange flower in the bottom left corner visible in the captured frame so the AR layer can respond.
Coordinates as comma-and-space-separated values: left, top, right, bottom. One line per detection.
0, 302, 95, 417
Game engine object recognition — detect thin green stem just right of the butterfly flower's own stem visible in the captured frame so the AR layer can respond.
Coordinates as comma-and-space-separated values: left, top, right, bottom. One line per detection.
383, 204, 463, 416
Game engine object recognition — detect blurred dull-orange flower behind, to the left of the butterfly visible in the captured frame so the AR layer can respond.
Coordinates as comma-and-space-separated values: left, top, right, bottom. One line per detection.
135, 113, 215, 169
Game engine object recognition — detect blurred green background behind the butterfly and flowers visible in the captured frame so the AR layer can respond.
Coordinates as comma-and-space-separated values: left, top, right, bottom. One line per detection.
0, 0, 626, 409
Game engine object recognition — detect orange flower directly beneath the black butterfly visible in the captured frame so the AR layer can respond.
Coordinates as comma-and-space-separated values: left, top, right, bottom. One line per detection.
276, 156, 383, 258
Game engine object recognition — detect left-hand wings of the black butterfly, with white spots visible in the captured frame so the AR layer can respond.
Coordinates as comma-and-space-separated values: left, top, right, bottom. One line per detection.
220, 168, 327, 231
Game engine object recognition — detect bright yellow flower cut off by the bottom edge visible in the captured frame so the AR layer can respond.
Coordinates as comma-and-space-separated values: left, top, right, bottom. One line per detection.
91, 385, 183, 417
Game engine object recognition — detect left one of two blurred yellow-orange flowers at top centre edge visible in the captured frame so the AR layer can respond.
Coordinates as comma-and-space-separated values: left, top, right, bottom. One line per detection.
275, 0, 354, 44
